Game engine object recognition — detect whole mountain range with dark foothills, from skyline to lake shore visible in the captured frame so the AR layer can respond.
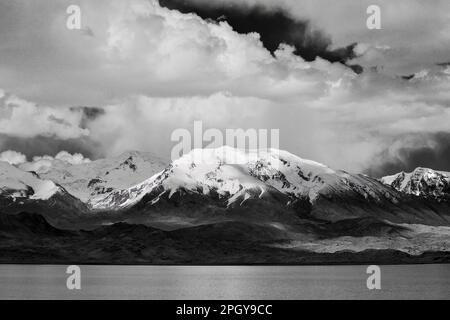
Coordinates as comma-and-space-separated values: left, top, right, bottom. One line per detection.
0, 147, 450, 263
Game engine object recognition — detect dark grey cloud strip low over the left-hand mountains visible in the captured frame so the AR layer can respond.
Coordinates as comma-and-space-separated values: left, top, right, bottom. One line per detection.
0, 134, 103, 160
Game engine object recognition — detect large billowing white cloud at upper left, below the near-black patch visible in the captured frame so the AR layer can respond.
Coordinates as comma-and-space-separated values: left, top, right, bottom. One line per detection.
0, 0, 351, 105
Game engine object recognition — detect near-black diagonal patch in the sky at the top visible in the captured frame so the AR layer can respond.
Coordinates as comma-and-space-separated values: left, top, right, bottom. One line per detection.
159, 0, 363, 73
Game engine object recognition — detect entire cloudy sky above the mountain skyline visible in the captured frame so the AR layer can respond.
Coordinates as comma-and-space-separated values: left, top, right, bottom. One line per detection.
0, 0, 450, 176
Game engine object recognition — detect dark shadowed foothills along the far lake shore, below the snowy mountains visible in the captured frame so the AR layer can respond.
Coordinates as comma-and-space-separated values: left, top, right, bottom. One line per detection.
0, 213, 450, 265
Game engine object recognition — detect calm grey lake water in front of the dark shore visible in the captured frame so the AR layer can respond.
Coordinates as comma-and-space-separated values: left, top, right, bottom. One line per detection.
0, 265, 450, 300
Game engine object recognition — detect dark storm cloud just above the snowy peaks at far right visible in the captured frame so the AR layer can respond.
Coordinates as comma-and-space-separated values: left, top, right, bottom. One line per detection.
366, 132, 450, 177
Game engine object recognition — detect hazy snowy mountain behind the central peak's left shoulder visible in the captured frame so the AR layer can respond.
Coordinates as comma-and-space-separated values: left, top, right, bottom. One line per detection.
20, 151, 164, 207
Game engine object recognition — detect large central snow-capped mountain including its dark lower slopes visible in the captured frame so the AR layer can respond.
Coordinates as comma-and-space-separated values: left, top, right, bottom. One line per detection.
87, 147, 450, 228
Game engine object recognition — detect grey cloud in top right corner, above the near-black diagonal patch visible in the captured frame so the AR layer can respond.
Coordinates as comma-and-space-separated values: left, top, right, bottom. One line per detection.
185, 0, 450, 75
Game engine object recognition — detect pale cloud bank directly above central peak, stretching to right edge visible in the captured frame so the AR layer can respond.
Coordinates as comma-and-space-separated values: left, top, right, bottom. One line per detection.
81, 63, 450, 171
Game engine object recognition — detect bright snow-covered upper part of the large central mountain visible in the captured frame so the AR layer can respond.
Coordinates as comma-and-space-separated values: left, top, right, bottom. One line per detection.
94, 147, 397, 209
